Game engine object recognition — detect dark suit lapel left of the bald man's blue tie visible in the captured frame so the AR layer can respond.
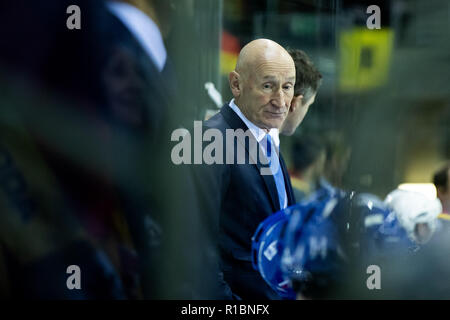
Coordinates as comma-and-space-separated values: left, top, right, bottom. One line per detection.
220, 104, 284, 212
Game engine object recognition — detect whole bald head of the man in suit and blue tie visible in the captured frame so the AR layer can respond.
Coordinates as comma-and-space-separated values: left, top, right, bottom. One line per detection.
229, 39, 295, 130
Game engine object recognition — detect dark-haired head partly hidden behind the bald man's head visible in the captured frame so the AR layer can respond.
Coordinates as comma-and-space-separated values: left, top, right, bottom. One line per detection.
280, 49, 322, 136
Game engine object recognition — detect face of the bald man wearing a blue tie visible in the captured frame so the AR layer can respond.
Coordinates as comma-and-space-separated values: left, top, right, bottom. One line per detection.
236, 61, 295, 129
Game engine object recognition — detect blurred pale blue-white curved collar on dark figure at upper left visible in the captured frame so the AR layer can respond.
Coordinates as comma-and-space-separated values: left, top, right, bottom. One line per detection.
106, 1, 167, 72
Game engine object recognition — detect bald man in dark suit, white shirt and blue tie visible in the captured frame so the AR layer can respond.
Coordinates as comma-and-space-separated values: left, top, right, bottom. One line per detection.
192, 39, 295, 299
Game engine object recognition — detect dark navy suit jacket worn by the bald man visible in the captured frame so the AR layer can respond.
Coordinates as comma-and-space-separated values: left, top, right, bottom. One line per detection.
193, 104, 295, 299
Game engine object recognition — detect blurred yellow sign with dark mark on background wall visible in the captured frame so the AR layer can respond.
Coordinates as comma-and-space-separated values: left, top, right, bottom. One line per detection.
339, 28, 394, 92
